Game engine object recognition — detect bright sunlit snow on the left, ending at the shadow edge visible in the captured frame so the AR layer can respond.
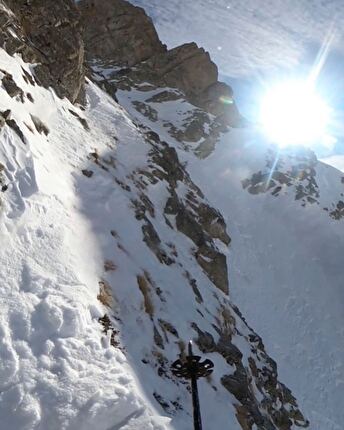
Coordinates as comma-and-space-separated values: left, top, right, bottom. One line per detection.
0, 50, 171, 430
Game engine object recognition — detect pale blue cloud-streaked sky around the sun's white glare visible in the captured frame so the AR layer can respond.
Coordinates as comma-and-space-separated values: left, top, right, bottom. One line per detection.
132, 0, 344, 160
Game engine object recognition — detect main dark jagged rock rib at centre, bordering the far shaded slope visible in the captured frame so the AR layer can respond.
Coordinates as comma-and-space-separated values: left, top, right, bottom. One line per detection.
145, 136, 230, 294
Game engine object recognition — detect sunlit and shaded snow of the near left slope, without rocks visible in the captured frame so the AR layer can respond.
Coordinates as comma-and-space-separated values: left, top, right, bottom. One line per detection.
0, 50, 263, 430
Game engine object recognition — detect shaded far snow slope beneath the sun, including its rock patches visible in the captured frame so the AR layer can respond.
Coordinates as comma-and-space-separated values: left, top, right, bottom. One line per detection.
110, 73, 344, 430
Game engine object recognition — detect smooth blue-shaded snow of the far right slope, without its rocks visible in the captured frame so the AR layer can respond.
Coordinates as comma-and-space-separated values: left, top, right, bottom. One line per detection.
187, 133, 344, 430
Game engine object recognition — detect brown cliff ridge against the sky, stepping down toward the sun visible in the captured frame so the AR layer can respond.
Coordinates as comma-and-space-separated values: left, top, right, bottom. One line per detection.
79, 0, 245, 126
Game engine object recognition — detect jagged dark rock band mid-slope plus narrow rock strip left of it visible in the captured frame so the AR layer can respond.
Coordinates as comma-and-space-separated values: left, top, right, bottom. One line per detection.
135, 131, 231, 294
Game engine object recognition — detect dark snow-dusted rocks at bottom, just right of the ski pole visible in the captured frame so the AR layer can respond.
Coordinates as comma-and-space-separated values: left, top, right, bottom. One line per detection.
192, 322, 309, 430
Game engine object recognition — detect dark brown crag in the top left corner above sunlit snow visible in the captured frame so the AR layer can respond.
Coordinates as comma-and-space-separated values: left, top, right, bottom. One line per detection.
0, 0, 85, 103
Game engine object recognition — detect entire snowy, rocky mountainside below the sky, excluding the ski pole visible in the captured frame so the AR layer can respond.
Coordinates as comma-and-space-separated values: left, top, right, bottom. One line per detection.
0, 0, 344, 430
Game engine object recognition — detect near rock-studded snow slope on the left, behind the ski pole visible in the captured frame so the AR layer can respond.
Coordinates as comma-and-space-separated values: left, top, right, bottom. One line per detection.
0, 51, 307, 430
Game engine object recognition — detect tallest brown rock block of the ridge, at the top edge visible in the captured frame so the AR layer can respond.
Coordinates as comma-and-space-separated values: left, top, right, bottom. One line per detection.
79, 0, 165, 66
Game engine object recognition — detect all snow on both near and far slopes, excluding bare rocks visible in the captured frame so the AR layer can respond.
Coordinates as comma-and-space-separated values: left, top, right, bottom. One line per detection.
0, 38, 344, 430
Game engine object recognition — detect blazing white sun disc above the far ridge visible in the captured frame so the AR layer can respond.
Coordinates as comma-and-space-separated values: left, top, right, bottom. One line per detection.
260, 81, 330, 147
